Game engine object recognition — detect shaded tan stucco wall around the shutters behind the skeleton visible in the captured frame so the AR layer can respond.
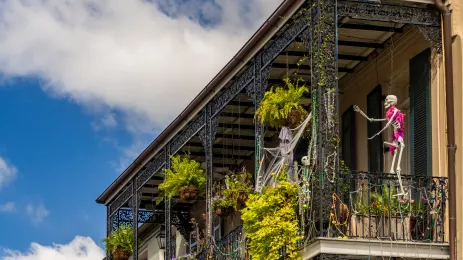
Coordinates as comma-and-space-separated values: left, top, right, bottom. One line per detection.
339, 29, 436, 175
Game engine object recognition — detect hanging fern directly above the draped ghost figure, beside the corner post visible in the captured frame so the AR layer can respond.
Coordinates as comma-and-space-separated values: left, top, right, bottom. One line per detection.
255, 78, 309, 128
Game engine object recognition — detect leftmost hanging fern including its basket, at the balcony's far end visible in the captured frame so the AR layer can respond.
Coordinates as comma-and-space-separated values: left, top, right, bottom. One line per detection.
103, 225, 134, 260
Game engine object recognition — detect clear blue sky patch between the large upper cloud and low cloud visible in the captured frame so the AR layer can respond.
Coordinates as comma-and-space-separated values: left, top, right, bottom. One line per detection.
0, 79, 135, 250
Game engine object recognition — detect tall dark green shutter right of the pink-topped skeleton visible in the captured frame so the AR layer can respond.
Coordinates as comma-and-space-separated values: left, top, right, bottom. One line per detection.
412, 49, 432, 176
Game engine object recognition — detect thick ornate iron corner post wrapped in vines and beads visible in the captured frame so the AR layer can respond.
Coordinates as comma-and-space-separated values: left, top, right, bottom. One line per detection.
306, 0, 339, 236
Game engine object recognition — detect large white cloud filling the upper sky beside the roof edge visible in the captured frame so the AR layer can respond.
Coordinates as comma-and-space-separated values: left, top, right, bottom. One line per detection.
0, 0, 282, 132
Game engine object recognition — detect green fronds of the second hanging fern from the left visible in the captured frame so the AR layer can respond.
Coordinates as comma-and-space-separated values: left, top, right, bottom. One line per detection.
156, 155, 206, 204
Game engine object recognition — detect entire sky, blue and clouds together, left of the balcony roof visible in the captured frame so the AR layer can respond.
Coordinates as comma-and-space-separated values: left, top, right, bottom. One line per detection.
0, 0, 281, 260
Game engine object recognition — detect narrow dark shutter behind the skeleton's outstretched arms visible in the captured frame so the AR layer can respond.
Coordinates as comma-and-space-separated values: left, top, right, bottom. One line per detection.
367, 85, 384, 173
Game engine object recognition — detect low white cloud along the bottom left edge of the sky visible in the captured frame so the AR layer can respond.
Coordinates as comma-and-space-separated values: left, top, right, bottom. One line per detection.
0, 236, 105, 260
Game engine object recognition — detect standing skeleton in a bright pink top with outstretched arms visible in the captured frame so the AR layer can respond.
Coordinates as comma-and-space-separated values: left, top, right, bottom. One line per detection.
354, 95, 405, 196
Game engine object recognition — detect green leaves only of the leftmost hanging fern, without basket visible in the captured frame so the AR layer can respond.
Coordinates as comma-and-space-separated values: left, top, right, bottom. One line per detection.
103, 224, 135, 254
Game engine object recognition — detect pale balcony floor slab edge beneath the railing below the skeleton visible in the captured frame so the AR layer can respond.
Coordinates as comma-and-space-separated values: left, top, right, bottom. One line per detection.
301, 238, 450, 260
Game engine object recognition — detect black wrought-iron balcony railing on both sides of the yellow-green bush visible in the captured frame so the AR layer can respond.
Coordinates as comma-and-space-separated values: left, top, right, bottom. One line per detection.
196, 171, 447, 260
